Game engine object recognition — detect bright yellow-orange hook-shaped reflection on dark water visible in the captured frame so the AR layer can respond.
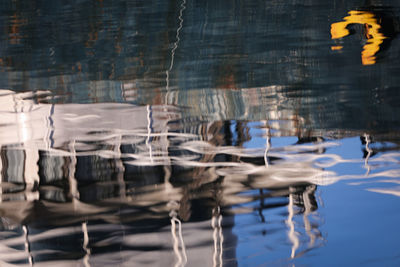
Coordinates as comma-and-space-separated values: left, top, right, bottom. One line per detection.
331, 10, 386, 65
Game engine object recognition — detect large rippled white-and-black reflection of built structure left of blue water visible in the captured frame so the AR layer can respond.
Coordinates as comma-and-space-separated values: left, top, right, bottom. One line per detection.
0, 89, 324, 266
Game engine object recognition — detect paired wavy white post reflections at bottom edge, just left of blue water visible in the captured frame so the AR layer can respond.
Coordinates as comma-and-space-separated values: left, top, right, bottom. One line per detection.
211, 207, 224, 267
